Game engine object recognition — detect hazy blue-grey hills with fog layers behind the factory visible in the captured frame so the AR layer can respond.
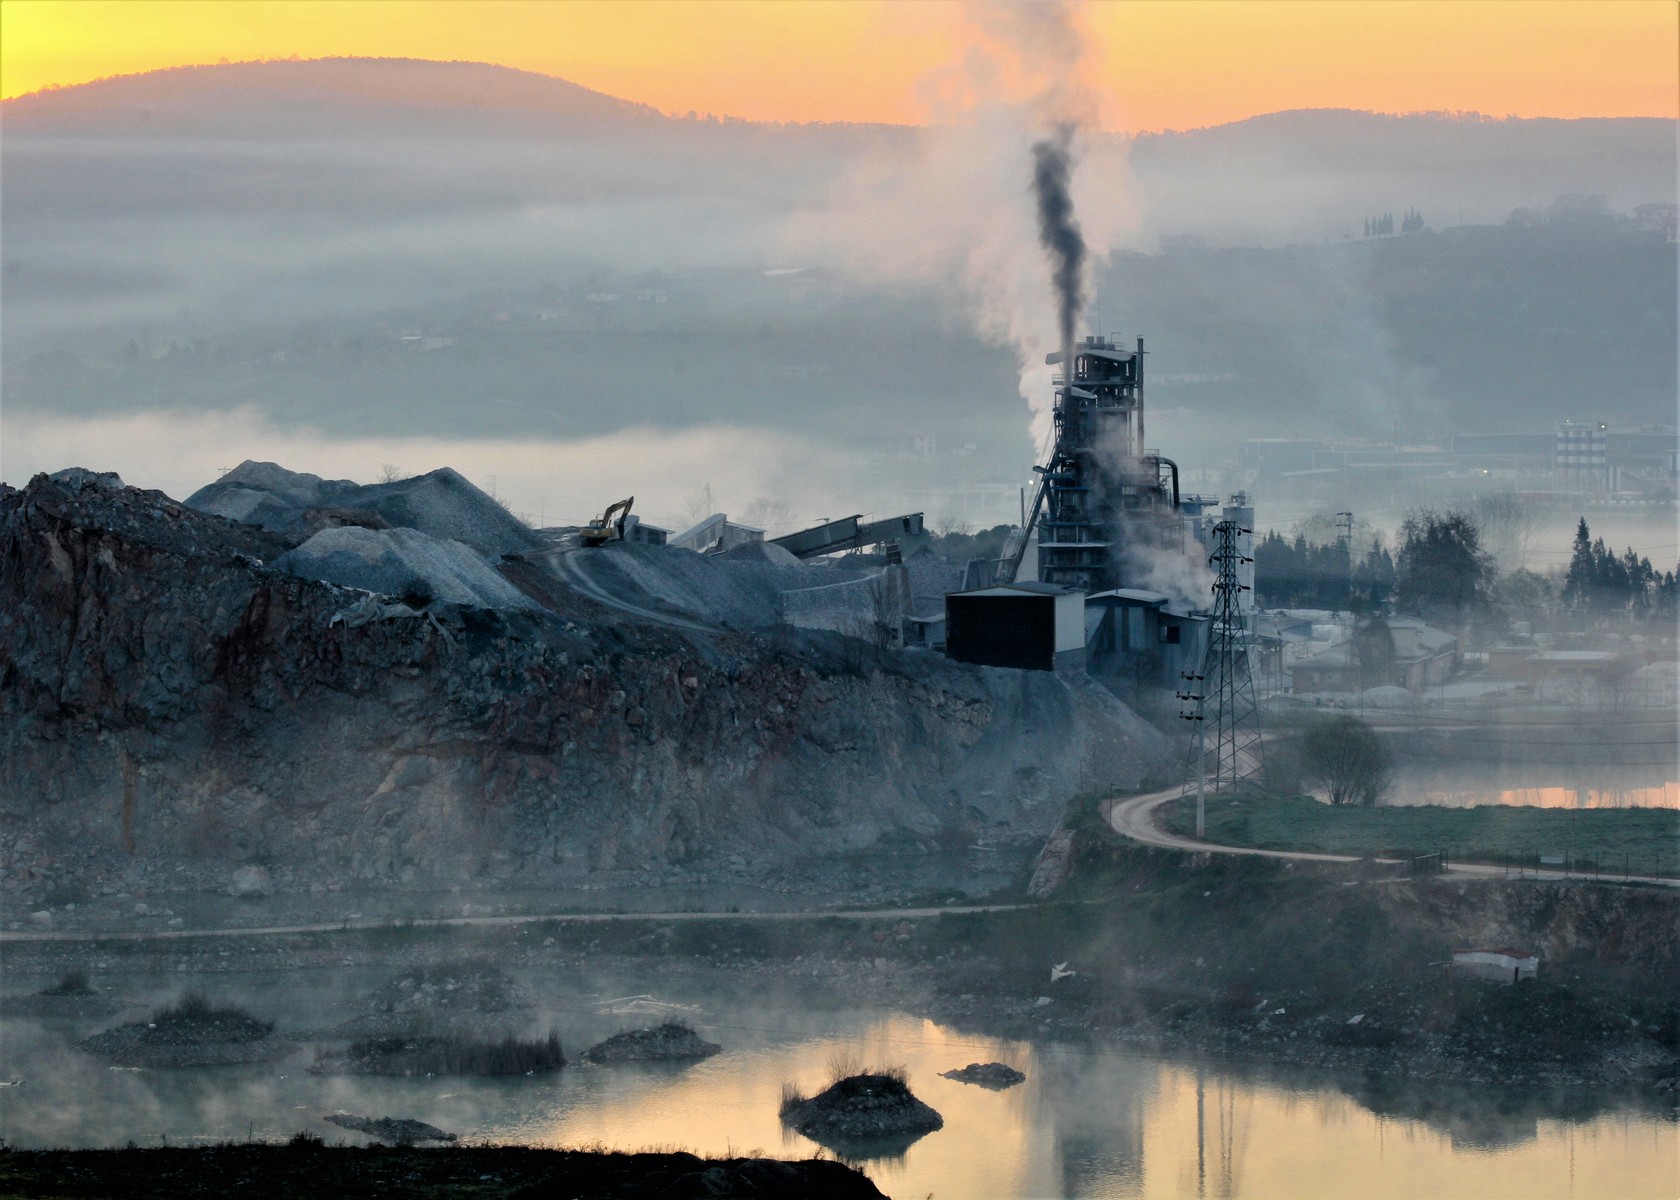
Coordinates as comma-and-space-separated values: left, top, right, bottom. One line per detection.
0, 61, 1675, 508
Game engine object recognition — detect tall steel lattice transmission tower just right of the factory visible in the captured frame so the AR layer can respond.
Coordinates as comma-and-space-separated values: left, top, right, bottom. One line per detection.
1179, 521, 1263, 792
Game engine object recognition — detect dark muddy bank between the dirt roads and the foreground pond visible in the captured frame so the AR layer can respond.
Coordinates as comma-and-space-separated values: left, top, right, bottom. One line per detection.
5, 850, 1680, 1104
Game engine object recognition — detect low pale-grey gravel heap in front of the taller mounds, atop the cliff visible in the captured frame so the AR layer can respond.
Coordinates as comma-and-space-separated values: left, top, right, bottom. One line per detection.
274, 526, 536, 608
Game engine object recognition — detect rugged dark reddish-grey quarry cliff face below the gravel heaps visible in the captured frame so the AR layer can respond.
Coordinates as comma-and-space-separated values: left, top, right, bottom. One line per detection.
0, 472, 1164, 911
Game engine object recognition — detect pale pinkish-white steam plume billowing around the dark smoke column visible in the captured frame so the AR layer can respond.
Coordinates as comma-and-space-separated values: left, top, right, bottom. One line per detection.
790, 2, 1136, 445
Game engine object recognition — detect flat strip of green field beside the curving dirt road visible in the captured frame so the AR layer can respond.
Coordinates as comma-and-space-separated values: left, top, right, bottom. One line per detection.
1163, 795, 1680, 876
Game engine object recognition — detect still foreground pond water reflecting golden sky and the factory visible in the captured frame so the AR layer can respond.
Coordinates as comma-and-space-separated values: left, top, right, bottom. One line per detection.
0, 971, 1680, 1198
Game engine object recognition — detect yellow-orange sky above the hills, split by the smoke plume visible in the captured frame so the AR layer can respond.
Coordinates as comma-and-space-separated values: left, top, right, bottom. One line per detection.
0, 0, 1680, 129
